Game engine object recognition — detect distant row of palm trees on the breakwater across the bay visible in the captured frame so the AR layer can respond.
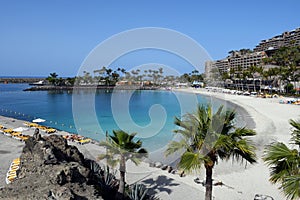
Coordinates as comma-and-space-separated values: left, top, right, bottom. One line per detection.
46, 67, 203, 86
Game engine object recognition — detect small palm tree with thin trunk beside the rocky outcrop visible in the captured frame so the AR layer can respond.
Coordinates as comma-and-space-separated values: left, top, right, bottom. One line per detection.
98, 130, 148, 196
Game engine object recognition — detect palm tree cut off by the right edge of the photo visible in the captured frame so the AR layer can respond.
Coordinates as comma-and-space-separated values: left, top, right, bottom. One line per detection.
263, 120, 300, 200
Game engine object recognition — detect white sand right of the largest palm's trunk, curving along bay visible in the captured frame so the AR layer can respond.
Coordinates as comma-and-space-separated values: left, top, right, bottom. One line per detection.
173, 89, 300, 200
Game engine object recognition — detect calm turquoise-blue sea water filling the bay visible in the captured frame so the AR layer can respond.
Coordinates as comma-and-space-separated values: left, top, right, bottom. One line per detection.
0, 84, 239, 150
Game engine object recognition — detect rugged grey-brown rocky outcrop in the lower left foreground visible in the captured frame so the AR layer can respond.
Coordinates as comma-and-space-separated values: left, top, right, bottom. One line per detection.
0, 135, 102, 200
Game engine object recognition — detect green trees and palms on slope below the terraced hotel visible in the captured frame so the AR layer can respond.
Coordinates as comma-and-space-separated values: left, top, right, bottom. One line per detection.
222, 46, 300, 93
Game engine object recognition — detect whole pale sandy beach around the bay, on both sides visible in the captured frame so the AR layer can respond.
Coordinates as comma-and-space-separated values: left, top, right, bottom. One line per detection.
0, 88, 300, 200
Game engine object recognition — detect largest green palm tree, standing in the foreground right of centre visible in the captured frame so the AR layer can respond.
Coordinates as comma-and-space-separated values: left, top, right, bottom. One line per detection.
166, 105, 256, 200
